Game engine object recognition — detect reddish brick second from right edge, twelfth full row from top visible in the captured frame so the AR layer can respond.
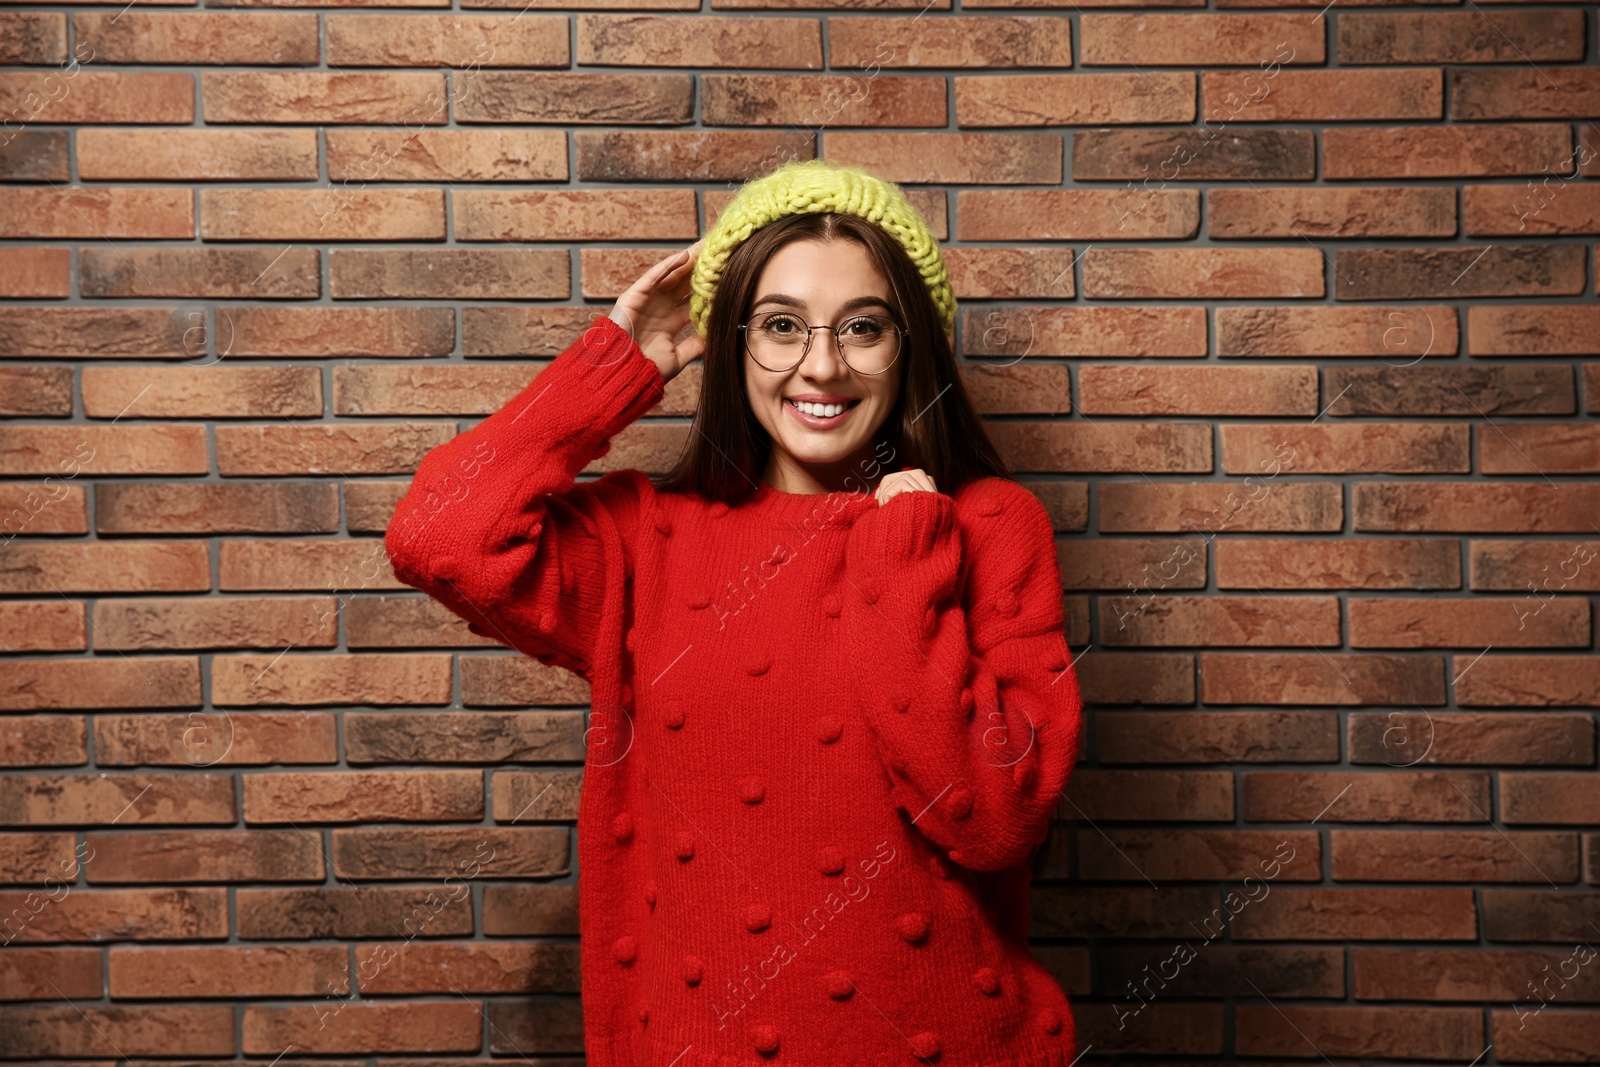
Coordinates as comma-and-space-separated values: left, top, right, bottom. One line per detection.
1200, 653, 1445, 704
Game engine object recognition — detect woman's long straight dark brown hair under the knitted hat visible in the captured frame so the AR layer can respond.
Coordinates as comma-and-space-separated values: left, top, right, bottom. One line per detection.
653, 211, 1011, 504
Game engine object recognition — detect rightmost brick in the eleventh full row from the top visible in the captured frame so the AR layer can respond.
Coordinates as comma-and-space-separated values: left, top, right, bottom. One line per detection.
1349, 597, 1590, 649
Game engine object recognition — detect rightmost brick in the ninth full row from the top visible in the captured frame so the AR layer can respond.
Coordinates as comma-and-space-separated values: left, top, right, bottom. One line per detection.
1354, 482, 1600, 533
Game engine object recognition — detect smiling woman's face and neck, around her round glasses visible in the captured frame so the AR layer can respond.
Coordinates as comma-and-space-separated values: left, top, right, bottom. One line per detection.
741, 238, 906, 493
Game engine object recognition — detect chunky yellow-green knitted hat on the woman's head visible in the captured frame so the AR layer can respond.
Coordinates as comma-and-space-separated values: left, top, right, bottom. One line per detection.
690, 160, 955, 338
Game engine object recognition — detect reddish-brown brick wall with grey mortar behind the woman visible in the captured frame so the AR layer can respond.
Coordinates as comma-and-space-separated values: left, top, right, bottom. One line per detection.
0, 0, 1600, 1067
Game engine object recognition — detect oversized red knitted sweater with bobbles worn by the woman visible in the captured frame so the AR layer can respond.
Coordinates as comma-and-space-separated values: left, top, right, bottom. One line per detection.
386, 317, 1082, 1067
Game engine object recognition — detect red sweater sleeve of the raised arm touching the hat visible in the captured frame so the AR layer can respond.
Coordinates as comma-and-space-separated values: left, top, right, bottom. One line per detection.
384, 317, 666, 678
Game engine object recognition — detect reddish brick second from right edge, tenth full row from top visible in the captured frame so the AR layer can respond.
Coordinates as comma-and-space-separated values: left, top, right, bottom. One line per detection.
1216, 537, 1461, 589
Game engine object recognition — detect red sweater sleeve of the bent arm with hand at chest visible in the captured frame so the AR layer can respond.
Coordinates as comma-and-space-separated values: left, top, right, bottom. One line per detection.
842, 478, 1083, 870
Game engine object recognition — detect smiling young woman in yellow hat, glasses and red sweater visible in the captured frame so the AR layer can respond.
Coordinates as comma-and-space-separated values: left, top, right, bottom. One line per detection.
387, 162, 1080, 1067
